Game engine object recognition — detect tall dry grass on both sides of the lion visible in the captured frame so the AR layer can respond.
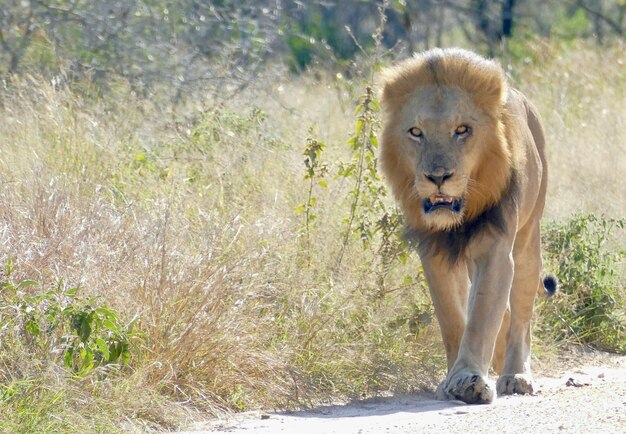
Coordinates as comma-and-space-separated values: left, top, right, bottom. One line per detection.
0, 41, 626, 432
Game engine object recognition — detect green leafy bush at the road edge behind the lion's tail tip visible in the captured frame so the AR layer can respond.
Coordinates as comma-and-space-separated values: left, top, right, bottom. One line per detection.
541, 214, 626, 352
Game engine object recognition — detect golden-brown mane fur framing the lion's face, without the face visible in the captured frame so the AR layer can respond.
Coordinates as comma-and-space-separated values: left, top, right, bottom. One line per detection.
381, 49, 519, 227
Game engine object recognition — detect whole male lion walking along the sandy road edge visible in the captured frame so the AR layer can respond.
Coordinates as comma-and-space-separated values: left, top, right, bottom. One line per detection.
381, 49, 556, 403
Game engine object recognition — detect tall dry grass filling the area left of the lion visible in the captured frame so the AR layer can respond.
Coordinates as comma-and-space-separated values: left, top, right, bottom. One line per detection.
0, 72, 438, 431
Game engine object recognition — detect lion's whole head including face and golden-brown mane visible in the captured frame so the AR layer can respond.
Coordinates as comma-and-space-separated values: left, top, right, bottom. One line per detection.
381, 49, 514, 232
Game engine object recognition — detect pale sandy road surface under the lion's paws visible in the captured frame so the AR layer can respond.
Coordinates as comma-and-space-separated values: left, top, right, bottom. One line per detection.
179, 353, 626, 434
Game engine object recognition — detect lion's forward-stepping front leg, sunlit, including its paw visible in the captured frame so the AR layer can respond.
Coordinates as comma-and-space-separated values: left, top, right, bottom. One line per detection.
437, 243, 513, 404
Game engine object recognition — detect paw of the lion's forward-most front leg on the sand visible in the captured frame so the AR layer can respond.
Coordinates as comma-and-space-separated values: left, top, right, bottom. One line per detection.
437, 372, 495, 404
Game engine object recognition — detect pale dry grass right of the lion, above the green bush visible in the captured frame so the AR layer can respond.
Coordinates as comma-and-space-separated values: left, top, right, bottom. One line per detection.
510, 42, 626, 219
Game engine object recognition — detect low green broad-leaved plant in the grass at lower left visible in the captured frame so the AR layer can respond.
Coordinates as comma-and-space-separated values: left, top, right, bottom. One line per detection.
0, 258, 139, 376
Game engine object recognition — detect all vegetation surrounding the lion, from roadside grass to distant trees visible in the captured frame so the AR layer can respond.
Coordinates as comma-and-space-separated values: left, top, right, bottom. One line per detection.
0, 0, 626, 433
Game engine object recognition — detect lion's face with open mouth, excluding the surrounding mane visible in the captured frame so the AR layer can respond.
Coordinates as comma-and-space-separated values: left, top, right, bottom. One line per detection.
386, 86, 490, 230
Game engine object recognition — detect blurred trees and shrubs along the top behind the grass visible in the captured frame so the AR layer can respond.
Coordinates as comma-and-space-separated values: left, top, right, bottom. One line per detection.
0, 0, 626, 99
